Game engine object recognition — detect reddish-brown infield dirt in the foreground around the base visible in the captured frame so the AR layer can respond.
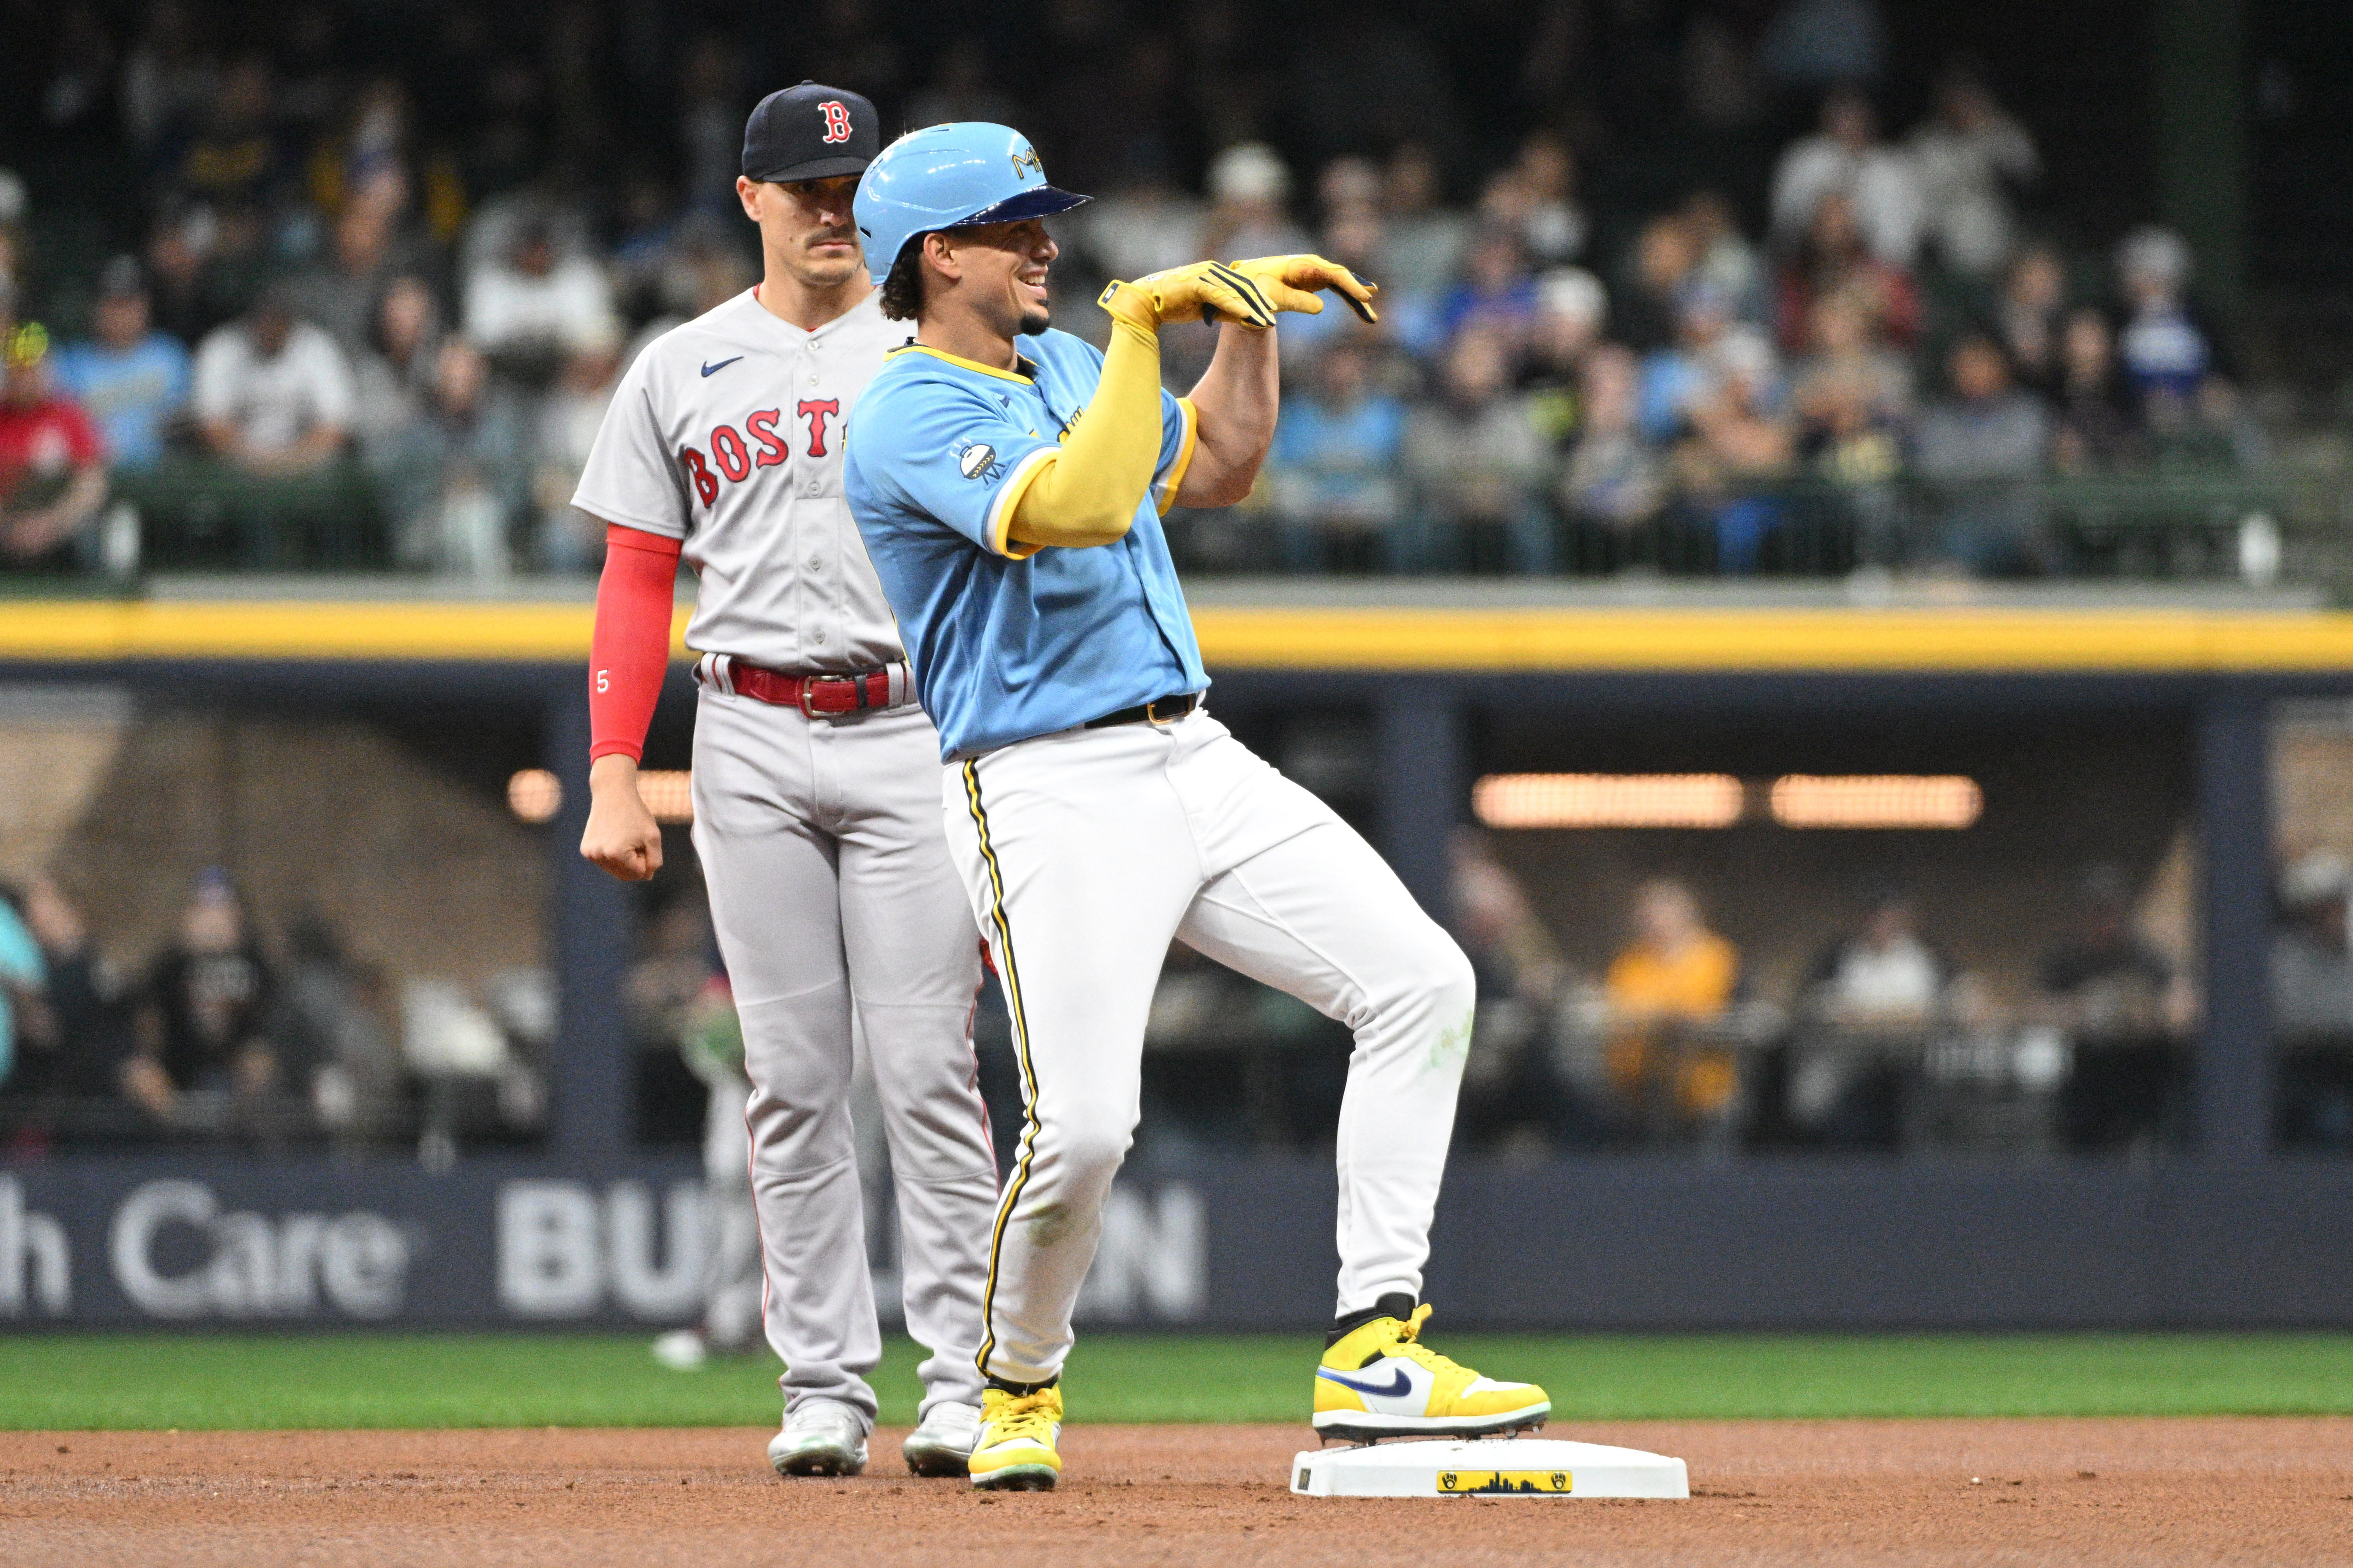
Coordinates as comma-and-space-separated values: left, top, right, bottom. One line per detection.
0, 1420, 2353, 1568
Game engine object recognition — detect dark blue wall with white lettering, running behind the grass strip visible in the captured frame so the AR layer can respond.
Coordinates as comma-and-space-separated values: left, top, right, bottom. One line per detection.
0, 1156, 2353, 1333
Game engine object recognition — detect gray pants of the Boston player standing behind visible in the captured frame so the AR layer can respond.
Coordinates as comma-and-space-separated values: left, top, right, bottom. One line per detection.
694, 685, 998, 1422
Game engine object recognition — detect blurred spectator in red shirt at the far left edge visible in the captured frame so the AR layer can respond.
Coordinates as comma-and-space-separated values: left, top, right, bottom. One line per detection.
0, 322, 106, 567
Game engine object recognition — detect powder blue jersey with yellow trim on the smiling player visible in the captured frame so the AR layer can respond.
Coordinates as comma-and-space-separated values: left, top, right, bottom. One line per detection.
842, 332, 1209, 761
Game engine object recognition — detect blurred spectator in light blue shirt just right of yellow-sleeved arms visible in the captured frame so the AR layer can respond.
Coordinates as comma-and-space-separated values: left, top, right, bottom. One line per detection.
1266, 339, 1405, 572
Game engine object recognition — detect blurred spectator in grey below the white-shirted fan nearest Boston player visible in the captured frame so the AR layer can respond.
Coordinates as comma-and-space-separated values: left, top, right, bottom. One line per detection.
369, 337, 529, 579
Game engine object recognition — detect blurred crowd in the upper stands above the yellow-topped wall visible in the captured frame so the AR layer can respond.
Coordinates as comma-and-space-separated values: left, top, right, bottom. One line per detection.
0, 0, 2259, 579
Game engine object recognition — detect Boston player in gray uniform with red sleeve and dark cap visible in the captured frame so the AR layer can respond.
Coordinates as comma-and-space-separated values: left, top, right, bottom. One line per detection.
572, 82, 998, 1476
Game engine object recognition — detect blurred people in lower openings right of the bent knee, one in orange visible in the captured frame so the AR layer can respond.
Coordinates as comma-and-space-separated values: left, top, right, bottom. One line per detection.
1454, 836, 2277, 1156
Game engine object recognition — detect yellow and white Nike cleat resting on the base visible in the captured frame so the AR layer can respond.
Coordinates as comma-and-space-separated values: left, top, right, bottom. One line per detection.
1316, 1297, 1553, 1443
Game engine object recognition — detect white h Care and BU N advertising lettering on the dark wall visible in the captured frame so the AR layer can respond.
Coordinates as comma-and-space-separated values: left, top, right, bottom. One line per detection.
0, 1161, 1209, 1330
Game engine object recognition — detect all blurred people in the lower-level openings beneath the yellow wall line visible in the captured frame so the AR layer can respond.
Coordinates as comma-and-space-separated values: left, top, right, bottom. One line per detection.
0, 829, 2353, 1161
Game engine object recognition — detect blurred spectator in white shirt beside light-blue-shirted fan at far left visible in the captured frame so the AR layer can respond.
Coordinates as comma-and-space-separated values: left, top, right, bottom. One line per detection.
195, 283, 353, 476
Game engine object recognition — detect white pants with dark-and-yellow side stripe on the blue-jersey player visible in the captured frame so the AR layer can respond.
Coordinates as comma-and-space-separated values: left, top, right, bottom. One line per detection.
944, 713, 1473, 1382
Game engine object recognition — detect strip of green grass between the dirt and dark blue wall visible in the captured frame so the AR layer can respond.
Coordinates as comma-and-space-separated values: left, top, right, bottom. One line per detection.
0, 1333, 2353, 1429
